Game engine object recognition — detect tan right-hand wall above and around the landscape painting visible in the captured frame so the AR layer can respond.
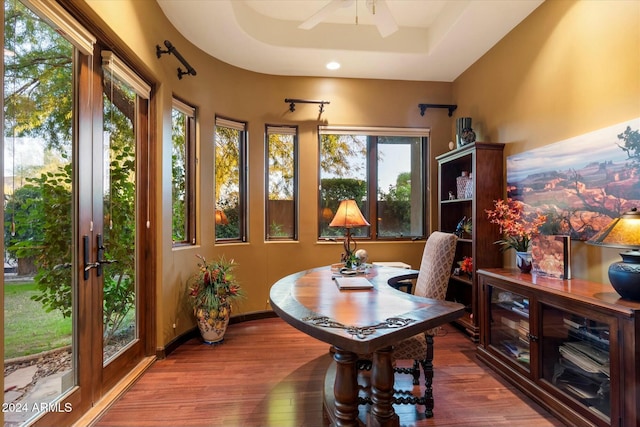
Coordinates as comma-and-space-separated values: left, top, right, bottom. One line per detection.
454, 0, 640, 283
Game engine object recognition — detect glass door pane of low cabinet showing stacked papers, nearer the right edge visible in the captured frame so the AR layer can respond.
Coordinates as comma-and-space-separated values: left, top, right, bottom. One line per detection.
541, 304, 612, 424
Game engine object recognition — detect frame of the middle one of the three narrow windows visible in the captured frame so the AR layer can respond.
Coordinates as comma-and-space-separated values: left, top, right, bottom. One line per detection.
213, 115, 249, 244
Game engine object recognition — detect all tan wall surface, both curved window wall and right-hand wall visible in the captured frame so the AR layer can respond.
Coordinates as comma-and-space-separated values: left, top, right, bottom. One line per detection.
77, 0, 640, 346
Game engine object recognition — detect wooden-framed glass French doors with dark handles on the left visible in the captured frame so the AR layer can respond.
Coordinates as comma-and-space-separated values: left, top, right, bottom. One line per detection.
3, 0, 153, 426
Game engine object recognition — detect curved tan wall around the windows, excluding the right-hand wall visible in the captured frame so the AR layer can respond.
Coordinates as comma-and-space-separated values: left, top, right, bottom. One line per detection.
82, 0, 453, 347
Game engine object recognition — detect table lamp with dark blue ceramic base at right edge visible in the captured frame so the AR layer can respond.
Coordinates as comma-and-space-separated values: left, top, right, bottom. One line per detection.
587, 208, 640, 301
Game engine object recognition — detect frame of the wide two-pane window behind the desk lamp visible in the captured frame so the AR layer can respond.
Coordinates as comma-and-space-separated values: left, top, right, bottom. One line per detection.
317, 126, 430, 241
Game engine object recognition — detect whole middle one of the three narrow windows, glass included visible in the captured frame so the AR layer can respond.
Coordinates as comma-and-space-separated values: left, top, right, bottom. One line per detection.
214, 117, 247, 242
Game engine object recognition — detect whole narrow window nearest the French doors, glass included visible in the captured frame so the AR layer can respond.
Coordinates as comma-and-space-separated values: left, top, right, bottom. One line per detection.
171, 99, 196, 245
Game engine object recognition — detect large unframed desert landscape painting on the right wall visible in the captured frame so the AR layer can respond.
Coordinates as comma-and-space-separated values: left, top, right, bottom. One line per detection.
507, 118, 640, 240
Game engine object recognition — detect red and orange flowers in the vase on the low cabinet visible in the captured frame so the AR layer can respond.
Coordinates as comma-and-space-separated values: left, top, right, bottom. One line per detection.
485, 199, 547, 252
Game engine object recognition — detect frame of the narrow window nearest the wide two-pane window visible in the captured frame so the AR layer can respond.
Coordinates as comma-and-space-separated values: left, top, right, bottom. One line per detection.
264, 124, 299, 241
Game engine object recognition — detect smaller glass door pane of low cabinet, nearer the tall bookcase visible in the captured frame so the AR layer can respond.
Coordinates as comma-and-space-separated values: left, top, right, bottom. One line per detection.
489, 286, 531, 372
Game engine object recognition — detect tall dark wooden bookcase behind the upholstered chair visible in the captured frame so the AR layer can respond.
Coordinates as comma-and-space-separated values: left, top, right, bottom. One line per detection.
436, 142, 504, 341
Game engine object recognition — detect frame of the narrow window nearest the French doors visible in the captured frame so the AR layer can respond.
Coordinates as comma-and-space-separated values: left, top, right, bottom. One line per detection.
171, 97, 198, 247
